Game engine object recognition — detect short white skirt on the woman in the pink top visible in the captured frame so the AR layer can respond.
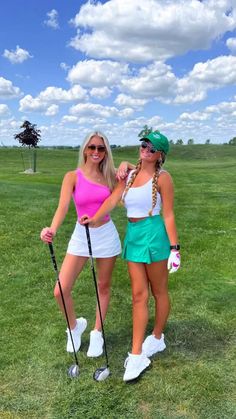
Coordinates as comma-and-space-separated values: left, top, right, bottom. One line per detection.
67, 220, 121, 258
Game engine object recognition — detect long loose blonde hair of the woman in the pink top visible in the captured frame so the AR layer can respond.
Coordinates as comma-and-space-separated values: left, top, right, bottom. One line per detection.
78, 131, 116, 191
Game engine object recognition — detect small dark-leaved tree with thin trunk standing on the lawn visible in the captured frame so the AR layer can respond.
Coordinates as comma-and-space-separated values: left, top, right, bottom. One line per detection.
14, 121, 41, 173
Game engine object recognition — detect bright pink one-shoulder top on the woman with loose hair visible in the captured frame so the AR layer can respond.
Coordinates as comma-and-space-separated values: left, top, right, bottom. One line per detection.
73, 169, 111, 221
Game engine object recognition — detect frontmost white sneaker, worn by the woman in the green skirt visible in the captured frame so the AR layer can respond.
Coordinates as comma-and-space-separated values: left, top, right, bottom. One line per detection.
123, 353, 151, 381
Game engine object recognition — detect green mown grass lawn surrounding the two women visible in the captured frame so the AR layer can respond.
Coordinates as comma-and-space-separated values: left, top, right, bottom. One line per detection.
0, 145, 236, 419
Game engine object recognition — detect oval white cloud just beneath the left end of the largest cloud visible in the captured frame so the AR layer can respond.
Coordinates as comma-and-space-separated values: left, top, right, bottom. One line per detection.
67, 60, 128, 87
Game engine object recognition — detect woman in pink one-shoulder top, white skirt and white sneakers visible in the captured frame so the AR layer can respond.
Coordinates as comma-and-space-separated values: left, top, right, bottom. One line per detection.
40, 132, 132, 357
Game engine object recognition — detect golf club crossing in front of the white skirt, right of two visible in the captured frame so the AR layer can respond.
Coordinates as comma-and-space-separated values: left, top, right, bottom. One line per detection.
85, 224, 110, 381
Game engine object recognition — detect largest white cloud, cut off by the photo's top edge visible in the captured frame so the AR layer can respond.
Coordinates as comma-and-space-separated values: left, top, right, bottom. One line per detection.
70, 0, 236, 62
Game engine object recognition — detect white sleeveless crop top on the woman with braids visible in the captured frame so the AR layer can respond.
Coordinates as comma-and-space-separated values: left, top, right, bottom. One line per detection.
121, 170, 161, 218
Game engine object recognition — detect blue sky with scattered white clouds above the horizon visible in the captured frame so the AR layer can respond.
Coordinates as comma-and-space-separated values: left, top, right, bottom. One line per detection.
0, 0, 236, 146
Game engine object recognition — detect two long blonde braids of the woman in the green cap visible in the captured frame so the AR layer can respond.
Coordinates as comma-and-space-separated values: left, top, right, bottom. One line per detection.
122, 152, 165, 217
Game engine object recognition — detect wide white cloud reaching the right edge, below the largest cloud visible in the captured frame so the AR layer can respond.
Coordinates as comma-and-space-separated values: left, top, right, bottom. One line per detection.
118, 55, 236, 107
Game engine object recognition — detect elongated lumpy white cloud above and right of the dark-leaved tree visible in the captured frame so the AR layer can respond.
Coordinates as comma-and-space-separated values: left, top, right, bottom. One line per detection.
19, 85, 87, 112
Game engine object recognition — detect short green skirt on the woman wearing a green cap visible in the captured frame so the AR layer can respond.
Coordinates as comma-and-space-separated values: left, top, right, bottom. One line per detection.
122, 215, 170, 263
